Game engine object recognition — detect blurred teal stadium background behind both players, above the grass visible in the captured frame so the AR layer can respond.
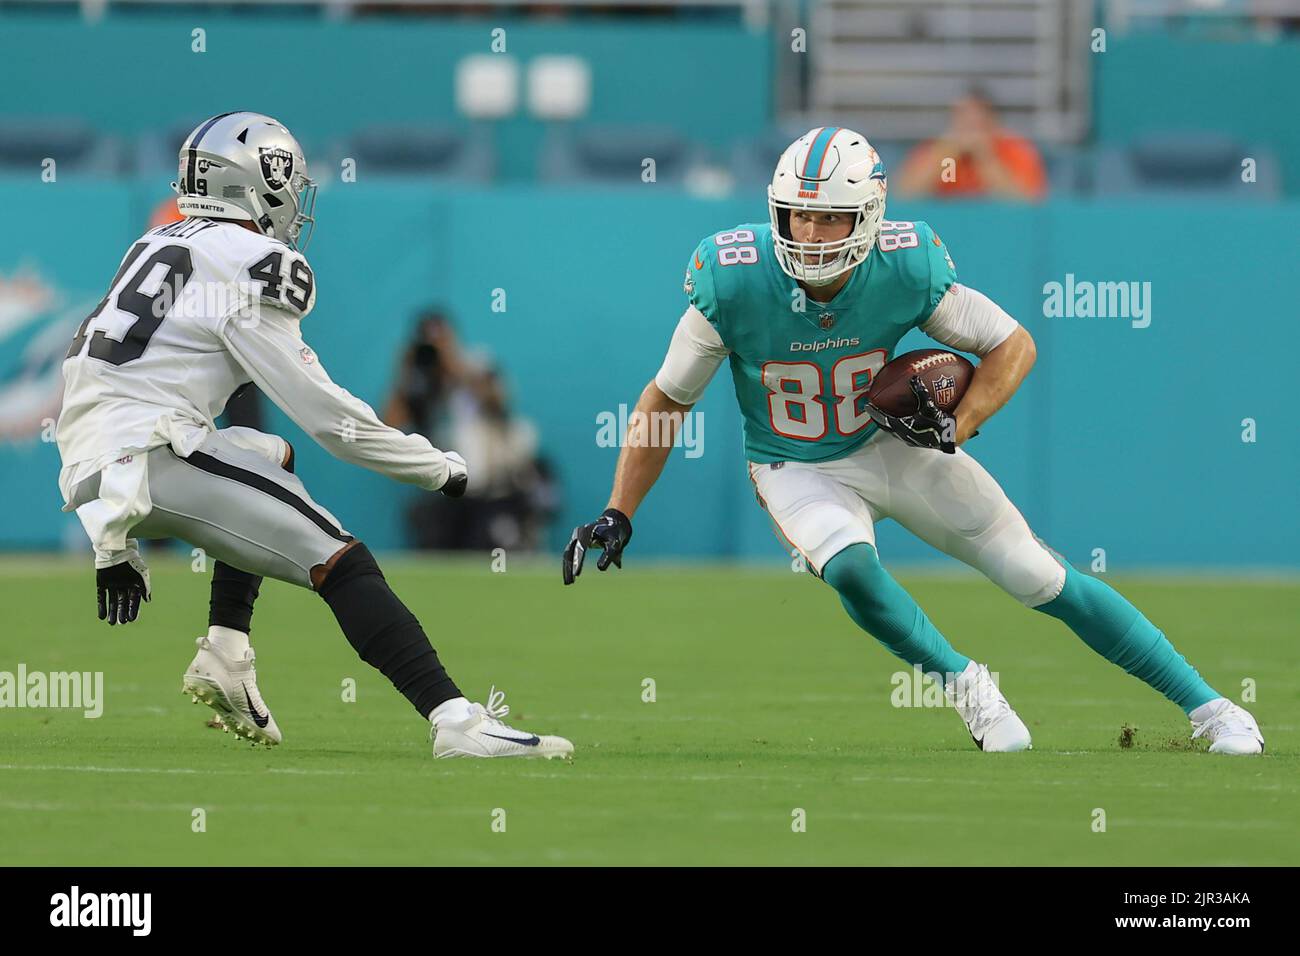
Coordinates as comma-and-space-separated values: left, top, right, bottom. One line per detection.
0, 0, 1300, 570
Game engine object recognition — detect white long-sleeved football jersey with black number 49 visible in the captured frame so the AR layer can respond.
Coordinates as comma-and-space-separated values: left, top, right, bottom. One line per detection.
56, 219, 450, 550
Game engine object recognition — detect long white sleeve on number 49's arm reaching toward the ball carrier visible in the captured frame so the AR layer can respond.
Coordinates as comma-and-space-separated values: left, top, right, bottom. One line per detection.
221, 306, 449, 492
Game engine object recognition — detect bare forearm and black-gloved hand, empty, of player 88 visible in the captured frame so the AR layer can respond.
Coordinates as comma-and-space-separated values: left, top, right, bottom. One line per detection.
563, 381, 692, 584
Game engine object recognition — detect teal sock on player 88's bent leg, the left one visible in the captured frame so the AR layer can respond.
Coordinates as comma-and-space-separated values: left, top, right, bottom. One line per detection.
822, 544, 970, 675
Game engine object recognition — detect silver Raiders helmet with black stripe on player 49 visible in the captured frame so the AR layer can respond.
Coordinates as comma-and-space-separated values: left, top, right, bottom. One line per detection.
172, 112, 316, 248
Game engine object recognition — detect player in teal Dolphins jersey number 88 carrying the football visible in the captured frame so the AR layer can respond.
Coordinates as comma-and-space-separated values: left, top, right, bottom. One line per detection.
563, 126, 1264, 754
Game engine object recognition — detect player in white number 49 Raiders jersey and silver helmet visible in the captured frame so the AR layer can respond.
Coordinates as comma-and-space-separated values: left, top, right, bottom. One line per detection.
57, 112, 573, 757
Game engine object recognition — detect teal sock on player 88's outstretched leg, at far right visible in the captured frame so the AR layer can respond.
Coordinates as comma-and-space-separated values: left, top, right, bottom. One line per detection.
1035, 564, 1222, 714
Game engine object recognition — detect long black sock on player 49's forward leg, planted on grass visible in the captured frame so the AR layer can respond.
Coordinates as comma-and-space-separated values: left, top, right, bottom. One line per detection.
319, 544, 464, 718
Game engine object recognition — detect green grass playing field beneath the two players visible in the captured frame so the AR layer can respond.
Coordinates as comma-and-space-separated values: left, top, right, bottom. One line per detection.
0, 555, 1300, 865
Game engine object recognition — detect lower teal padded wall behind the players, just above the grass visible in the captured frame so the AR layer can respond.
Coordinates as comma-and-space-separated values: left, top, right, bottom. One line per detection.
0, 182, 1300, 566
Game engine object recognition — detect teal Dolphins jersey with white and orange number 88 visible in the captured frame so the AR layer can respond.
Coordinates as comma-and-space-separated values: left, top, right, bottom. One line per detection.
685, 221, 957, 463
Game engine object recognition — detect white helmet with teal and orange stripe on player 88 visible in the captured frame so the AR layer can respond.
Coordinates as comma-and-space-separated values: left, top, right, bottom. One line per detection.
767, 126, 887, 286
